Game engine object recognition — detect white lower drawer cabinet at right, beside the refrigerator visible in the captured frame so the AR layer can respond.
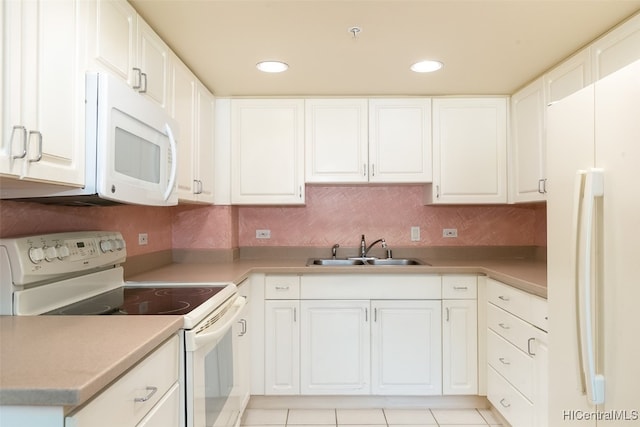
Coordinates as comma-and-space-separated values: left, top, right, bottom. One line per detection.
487, 279, 548, 427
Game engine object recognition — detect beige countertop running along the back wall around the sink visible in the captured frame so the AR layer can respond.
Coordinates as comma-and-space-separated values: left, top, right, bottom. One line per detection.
127, 259, 547, 298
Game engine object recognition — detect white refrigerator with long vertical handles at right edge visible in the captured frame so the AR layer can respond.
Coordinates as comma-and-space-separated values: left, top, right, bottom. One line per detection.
547, 58, 640, 427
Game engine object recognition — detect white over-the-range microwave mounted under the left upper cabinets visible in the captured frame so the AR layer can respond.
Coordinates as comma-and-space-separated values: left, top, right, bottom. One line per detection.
0, 73, 178, 206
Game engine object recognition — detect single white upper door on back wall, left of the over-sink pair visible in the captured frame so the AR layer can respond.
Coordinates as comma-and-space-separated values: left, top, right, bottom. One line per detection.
231, 99, 304, 204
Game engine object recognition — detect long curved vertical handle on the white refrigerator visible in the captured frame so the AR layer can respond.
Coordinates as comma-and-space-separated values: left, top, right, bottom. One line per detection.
574, 169, 604, 405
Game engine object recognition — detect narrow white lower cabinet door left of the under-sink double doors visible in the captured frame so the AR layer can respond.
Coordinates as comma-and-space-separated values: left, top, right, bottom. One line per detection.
264, 300, 300, 394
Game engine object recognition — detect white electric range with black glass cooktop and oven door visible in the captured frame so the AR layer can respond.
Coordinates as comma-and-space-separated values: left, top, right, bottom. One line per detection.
0, 231, 249, 427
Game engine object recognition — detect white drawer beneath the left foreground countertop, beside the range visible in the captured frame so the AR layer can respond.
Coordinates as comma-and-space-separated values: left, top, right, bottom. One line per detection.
65, 336, 178, 427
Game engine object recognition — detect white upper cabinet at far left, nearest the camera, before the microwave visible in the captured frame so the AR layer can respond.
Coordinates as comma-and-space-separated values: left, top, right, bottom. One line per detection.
0, 0, 86, 186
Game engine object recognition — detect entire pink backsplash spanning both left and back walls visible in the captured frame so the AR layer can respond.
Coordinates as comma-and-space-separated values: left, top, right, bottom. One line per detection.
0, 185, 546, 256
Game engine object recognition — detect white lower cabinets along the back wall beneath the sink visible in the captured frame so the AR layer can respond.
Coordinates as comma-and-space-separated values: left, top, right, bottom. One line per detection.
264, 274, 478, 395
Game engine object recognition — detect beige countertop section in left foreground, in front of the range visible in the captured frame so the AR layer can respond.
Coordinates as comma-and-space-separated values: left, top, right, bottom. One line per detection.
0, 316, 182, 408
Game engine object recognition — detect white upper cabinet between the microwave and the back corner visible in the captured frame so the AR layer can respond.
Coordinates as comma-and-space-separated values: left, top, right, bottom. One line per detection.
170, 57, 214, 203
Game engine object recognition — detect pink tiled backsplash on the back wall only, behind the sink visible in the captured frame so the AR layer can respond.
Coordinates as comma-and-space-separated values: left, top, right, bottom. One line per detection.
239, 185, 546, 247
